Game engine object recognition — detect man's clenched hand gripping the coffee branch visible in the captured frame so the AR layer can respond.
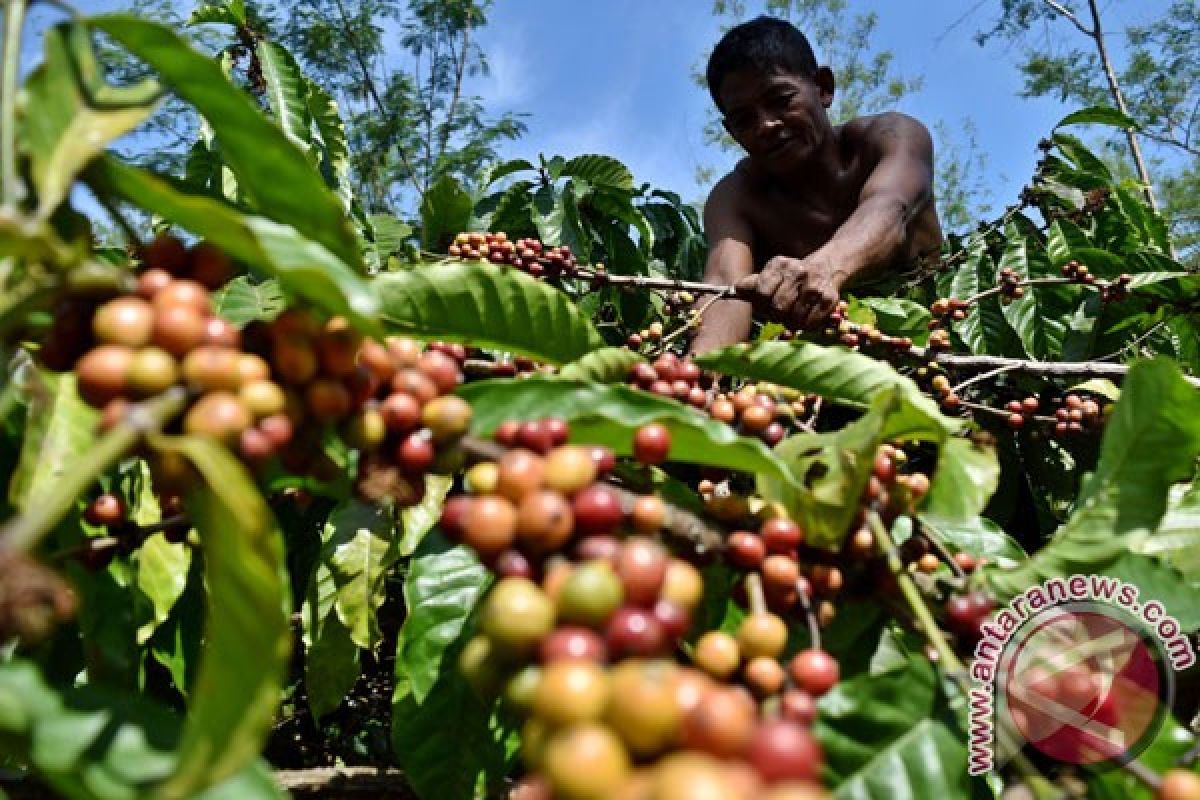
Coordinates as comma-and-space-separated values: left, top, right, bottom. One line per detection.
734, 255, 846, 330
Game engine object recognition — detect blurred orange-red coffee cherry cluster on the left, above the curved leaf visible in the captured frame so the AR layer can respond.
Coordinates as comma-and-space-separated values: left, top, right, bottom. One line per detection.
39, 236, 470, 505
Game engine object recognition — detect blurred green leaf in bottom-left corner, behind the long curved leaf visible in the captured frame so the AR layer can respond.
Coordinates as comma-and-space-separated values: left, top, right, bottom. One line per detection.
0, 660, 286, 800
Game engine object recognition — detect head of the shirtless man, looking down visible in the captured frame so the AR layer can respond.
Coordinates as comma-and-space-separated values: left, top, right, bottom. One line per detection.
706, 17, 834, 172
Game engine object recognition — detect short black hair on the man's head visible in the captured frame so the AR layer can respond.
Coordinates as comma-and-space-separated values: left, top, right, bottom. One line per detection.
704, 17, 817, 108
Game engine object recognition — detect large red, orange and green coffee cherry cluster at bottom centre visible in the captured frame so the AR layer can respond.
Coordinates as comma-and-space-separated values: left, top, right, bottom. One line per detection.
442, 419, 824, 800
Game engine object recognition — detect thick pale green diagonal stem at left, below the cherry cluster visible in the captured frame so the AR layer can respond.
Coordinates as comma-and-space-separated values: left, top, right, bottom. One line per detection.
0, 387, 187, 553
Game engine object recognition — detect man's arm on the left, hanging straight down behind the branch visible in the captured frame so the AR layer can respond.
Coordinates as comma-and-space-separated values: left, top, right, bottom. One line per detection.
690, 175, 754, 353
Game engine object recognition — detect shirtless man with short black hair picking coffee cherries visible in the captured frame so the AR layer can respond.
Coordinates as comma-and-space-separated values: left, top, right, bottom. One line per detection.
691, 17, 942, 353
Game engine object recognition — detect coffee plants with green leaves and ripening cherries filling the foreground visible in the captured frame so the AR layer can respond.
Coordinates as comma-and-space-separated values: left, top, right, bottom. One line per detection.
0, 2, 1200, 800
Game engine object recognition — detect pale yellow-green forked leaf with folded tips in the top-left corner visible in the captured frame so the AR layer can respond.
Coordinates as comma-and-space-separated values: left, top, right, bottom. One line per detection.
19, 25, 158, 218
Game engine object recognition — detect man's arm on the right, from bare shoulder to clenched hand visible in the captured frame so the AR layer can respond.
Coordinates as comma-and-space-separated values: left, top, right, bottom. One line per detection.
739, 113, 934, 327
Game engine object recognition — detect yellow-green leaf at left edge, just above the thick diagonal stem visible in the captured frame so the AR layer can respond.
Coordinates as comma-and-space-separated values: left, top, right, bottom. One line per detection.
8, 368, 97, 509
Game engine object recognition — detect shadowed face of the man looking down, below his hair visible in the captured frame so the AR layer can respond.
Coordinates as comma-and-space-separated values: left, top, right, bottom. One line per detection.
719, 71, 833, 172
